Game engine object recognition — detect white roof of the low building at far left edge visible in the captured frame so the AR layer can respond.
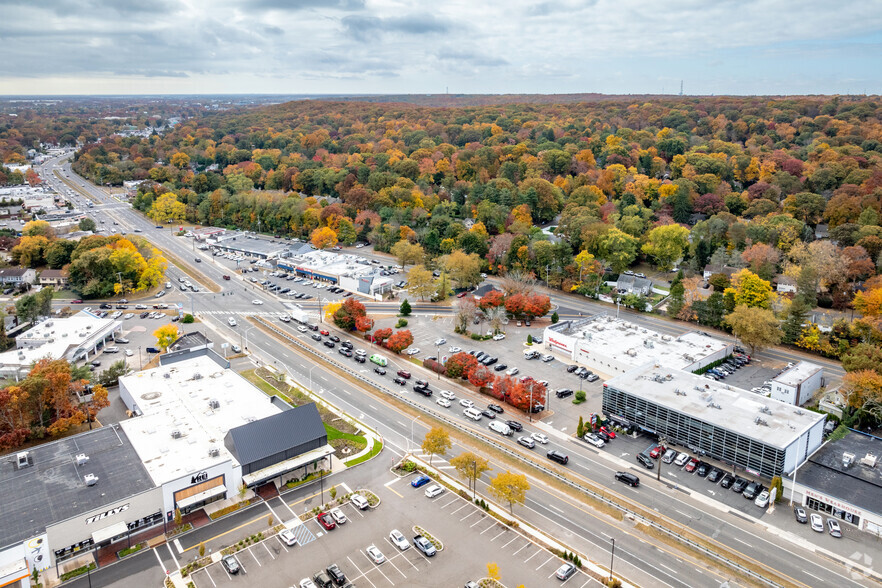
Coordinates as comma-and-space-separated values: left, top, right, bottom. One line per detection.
0, 311, 121, 366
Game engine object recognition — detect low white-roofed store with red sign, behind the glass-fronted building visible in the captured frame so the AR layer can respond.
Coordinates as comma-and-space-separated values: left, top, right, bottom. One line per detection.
543, 314, 733, 375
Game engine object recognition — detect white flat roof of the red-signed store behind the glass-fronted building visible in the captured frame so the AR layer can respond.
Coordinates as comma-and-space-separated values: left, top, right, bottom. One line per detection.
562, 315, 730, 369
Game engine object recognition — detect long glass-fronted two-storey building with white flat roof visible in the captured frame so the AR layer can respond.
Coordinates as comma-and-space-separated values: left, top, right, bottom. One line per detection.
603, 363, 825, 478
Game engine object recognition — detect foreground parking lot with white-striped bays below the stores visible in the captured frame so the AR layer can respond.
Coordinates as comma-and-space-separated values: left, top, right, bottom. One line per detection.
188, 473, 592, 588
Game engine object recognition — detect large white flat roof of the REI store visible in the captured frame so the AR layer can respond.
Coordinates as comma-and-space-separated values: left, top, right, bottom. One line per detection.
120, 356, 280, 486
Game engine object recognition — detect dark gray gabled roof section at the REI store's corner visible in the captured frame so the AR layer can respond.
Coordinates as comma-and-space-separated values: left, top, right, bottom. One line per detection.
224, 403, 328, 464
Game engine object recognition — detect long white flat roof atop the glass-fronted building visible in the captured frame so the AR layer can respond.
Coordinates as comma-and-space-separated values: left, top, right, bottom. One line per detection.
604, 363, 825, 449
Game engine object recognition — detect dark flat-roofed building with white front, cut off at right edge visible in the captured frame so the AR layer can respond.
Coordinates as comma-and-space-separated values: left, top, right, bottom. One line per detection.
794, 431, 882, 536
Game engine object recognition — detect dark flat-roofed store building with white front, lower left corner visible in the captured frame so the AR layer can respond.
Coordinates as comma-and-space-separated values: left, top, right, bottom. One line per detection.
0, 425, 162, 569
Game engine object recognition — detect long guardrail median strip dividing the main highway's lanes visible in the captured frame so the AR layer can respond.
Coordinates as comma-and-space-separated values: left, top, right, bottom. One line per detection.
253, 316, 783, 587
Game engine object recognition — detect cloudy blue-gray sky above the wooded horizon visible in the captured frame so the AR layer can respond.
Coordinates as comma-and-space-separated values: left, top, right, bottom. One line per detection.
0, 0, 882, 94
